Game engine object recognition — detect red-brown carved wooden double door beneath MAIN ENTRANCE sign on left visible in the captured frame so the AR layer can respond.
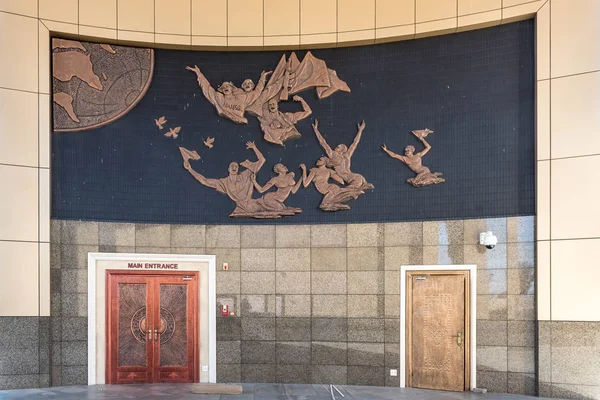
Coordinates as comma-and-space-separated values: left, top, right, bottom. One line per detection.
106, 271, 198, 384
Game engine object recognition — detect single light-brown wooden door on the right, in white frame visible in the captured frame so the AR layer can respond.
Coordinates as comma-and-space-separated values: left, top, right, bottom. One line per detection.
406, 271, 470, 391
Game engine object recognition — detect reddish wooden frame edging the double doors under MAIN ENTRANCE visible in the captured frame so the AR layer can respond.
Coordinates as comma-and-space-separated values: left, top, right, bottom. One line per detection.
105, 269, 200, 384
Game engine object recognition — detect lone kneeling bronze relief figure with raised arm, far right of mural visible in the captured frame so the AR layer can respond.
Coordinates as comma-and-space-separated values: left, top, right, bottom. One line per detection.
381, 129, 446, 187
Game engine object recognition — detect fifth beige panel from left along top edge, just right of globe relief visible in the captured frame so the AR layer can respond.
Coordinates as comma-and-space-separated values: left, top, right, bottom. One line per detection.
154, 0, 192, 35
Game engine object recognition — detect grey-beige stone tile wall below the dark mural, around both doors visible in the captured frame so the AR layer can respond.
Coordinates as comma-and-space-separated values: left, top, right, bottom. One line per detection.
51, 217, 536, 394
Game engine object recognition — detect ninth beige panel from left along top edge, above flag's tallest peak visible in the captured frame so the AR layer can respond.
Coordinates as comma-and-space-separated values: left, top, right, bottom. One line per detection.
300, 0, 337, 34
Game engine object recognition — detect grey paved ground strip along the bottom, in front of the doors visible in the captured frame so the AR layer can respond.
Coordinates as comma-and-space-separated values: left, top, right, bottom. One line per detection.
0, 383, 556, 400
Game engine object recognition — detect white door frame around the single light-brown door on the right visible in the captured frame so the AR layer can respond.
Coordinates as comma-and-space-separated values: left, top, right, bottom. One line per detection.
399, 264, 477, 389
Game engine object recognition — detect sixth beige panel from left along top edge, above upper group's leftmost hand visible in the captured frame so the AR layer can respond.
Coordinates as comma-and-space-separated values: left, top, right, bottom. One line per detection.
192, 0, 227, 36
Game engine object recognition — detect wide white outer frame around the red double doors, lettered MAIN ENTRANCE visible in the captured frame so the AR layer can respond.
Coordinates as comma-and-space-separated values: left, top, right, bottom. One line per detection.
87, 253, 217, 385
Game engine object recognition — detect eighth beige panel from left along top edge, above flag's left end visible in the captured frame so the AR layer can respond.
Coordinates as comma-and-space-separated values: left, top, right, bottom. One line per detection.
265, 0, 300, 36
